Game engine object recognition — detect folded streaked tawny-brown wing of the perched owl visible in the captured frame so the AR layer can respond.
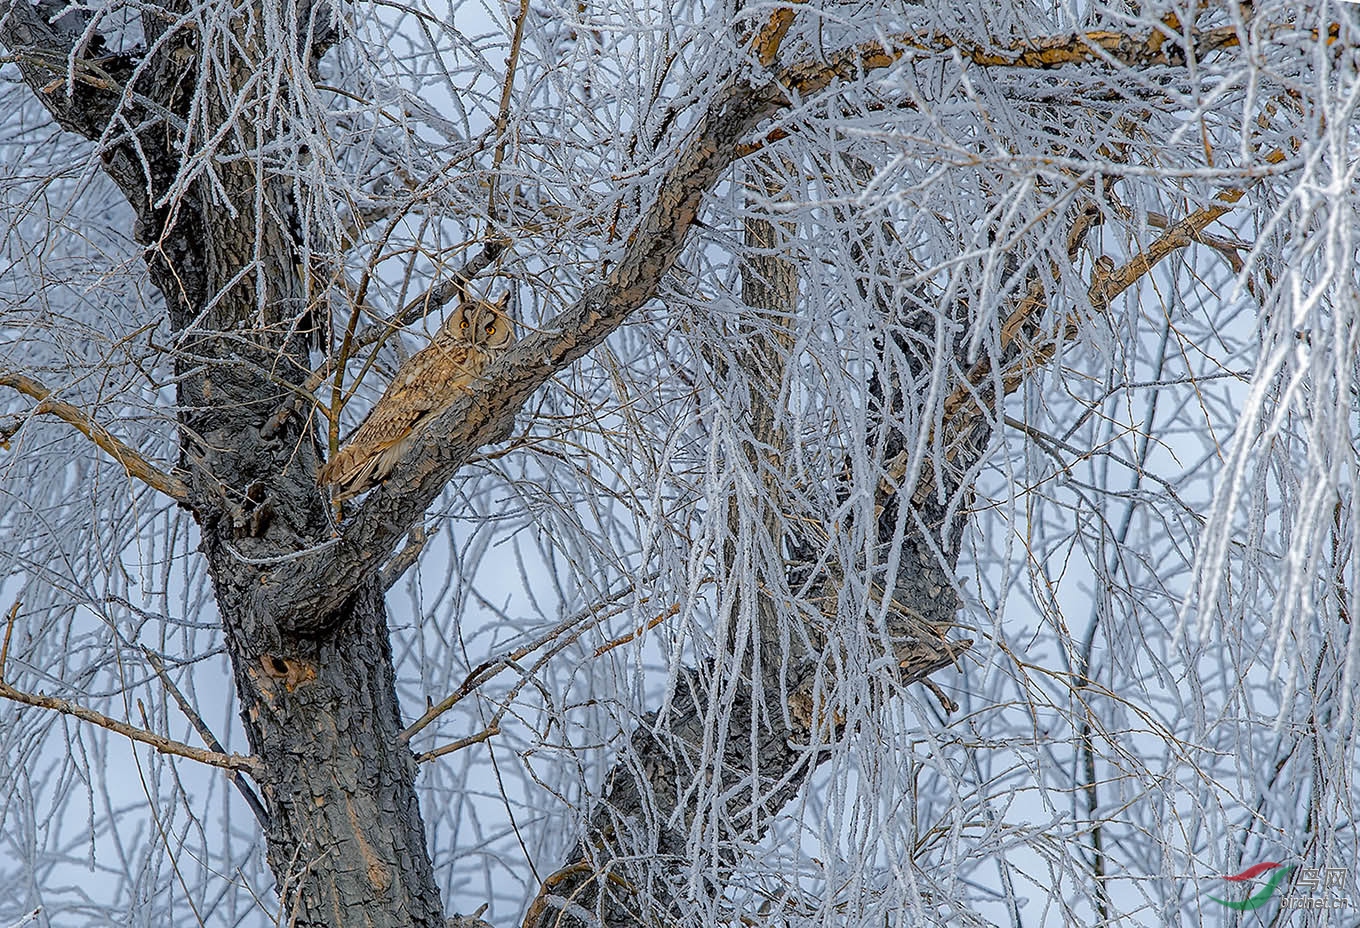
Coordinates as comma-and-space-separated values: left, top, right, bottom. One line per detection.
317, 342, 472, 499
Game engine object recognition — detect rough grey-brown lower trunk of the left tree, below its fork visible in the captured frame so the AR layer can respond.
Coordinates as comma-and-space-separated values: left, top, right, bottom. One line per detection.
218, 574, 443, 927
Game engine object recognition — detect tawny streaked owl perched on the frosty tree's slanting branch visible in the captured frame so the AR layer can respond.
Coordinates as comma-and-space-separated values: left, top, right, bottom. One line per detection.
317, 294, 514, 501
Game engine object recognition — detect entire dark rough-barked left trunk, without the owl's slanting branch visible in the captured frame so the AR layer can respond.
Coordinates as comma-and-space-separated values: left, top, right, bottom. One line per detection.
0, 1, 443, 928
